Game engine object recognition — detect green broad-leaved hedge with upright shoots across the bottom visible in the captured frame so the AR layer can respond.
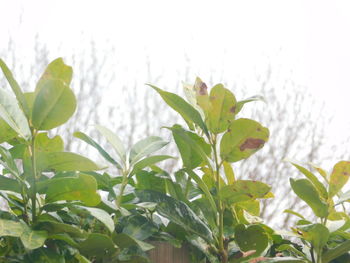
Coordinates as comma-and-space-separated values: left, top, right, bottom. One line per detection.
0, 59, 350, 263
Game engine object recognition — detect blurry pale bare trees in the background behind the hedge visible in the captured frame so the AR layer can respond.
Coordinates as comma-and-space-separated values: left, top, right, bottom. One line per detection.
0, 38, 348, 227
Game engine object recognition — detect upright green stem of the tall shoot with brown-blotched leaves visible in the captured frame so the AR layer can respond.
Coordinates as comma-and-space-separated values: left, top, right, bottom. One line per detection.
211, 135, 228, 263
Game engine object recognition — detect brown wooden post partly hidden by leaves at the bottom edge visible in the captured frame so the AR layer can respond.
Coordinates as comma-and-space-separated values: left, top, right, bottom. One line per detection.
149, 241, 190, 263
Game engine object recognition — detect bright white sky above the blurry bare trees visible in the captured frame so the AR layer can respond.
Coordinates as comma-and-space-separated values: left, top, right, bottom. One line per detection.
0, 0, 350, 163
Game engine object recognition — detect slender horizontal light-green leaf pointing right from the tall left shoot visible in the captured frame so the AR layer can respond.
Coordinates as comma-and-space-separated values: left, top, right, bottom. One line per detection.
43, 152, 102, 172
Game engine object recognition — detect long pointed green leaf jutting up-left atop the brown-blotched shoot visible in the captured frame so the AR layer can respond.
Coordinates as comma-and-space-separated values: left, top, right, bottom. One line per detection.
148, 84, 208, 135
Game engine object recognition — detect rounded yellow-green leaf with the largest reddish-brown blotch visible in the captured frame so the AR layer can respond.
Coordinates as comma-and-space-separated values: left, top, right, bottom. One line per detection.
220, 119, 269, 162
